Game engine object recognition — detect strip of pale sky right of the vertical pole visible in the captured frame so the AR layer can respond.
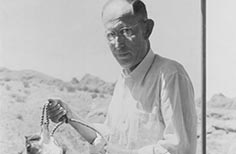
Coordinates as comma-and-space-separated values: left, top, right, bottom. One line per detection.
207, 0, 236, 97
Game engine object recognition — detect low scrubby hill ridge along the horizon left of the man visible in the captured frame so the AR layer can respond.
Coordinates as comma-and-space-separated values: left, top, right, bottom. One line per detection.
0, 68, 115, 94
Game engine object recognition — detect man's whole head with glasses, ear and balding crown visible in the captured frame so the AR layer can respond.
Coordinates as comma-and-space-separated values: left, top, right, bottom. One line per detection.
102, 0, 154, 71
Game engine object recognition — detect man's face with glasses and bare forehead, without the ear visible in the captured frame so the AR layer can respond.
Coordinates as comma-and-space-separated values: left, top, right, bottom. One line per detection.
103, 2, 147, 69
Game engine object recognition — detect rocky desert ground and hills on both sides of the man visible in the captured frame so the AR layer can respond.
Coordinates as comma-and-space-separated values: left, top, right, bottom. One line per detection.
0, 68, 236, 154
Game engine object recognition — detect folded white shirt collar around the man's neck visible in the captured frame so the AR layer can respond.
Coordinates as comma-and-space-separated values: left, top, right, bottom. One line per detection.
121, 49, 155, 79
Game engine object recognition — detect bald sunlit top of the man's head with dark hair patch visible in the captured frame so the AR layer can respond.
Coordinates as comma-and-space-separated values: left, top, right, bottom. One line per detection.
102, 0, 147, 23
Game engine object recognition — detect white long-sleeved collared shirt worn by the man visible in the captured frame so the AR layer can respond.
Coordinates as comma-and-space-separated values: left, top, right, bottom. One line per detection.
91, 50, 197, 154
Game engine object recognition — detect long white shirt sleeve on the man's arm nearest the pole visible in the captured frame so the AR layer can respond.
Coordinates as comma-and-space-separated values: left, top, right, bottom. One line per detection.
139, 72, 197, 154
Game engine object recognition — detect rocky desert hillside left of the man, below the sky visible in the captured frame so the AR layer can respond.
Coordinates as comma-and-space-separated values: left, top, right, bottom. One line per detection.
0, 68, 114, 154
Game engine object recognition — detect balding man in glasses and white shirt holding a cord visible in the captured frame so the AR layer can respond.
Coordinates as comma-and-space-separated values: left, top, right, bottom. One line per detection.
49, 0, 197, 154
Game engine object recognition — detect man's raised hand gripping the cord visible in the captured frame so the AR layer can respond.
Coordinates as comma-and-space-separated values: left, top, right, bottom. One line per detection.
48, 99, 73, 123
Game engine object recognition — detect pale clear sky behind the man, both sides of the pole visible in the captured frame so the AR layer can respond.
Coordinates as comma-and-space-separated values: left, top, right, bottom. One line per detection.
0, 0, 236, 98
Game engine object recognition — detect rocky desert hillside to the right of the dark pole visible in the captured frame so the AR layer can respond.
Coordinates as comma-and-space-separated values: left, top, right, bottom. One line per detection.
207, 93, 236, 154
